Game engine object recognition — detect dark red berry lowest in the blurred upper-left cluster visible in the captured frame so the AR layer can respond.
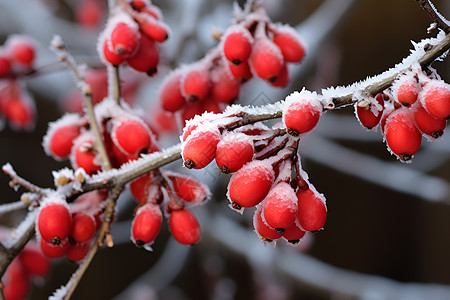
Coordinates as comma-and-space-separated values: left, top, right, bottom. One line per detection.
127, 33, 159, 76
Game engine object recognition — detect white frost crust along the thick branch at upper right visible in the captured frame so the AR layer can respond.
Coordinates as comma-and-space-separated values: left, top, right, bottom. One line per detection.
322, 31, 448, 107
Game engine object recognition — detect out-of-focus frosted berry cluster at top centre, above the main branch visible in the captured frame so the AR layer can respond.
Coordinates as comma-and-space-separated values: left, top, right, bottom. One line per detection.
159, 2, 305, 126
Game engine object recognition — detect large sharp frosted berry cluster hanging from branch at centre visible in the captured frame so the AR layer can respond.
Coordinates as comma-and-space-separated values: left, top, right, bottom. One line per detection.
181, 91, 327, 243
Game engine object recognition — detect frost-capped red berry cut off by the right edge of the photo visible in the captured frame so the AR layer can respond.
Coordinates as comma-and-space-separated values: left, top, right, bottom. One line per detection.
420, 79, 450, 119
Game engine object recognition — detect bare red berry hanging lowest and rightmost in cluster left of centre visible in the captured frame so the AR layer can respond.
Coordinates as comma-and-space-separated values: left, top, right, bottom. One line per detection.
169, 208, 201, 245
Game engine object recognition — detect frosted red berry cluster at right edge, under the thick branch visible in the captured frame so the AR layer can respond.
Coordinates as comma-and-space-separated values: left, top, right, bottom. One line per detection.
355, 70, 450, 162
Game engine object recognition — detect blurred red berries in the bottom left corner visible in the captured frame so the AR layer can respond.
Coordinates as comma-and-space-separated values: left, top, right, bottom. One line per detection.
2, 241, 50, 300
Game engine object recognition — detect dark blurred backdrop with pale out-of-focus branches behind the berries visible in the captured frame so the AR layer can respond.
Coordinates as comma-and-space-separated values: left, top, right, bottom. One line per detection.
0, 0, 450, 300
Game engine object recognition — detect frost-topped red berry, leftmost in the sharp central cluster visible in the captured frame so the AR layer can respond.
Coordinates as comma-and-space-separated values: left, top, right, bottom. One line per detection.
181, 130, 219, 169
